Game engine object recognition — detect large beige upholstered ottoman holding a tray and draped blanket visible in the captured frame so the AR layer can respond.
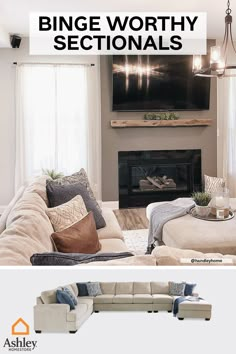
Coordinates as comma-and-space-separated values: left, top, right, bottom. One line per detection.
146, 198, 236, 255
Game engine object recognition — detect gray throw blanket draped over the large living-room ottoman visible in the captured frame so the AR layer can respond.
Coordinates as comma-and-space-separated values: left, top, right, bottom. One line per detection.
148, 202, 194, 246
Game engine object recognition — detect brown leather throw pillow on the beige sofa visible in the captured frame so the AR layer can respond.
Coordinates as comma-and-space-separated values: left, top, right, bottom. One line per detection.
52, 212, 101, 254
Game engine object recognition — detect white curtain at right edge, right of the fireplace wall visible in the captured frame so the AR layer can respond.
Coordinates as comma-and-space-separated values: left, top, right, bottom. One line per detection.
217, 71, 236, 197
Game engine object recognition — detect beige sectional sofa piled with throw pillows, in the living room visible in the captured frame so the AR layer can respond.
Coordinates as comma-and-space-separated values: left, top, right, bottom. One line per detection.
0, 176, 128, 265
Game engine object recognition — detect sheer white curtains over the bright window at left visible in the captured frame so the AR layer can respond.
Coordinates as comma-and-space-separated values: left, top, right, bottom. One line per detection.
15, 64, 101, 198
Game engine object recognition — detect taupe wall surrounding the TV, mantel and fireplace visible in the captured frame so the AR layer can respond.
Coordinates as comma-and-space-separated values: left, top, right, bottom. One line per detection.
101, 56, 217, 201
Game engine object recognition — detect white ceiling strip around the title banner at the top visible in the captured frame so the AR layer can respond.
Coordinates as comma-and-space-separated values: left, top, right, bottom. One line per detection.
0, 0, 236, 38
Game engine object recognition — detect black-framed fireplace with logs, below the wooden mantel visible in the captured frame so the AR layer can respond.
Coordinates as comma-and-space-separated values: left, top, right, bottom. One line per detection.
118, 150, 202, 208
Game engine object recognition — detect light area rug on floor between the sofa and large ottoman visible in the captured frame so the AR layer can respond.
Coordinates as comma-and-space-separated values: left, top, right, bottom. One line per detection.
122, 229, 148, 255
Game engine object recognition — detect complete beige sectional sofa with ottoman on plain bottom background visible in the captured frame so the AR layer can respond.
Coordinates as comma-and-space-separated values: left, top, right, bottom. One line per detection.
34, 282, 212, 333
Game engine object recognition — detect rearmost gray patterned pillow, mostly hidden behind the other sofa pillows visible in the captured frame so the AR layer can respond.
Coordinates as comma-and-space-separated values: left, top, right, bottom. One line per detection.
51, 168, 102, 212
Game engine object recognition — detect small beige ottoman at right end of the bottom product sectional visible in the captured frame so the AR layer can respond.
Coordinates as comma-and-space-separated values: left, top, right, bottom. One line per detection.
177, 300, 212, 321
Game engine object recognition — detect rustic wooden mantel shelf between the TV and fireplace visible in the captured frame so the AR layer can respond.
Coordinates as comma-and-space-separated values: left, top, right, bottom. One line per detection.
111, 118, 212, 128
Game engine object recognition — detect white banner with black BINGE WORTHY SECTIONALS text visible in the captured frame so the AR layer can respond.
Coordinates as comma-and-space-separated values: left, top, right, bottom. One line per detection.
30, 12, 206, 55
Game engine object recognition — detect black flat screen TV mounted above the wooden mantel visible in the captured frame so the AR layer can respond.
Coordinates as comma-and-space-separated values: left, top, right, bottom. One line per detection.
112, 55, 210, 112
